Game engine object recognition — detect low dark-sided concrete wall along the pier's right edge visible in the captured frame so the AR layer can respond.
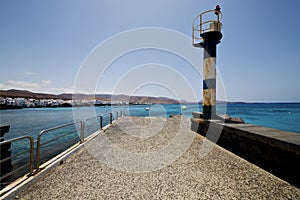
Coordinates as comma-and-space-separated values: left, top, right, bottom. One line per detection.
191, 112, 300, 188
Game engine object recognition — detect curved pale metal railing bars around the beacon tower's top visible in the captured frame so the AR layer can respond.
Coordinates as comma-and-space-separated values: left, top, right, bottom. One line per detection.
192, 10, 222, 44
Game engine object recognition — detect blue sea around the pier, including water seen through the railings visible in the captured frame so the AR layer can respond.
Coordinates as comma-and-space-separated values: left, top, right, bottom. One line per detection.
0, 103, 300, 180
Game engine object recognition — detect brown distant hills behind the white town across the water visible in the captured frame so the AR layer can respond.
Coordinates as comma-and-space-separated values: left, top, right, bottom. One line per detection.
0, 89, 179, 104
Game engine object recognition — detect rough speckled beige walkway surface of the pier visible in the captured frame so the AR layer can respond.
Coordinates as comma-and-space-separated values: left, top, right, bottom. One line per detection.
17, 116, 300, 199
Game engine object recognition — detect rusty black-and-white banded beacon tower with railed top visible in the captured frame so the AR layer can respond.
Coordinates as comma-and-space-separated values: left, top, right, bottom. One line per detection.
193, 5, 222, 120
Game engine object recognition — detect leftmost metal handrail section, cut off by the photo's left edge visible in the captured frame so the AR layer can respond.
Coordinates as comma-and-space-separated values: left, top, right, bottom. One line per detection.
0, 135, 34, 180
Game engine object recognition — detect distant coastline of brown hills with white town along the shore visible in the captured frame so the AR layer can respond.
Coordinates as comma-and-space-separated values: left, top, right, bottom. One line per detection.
0, 89, 183, 110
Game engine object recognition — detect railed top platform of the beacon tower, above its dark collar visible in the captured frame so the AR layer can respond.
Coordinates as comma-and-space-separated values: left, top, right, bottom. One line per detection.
192, 10, 222, 46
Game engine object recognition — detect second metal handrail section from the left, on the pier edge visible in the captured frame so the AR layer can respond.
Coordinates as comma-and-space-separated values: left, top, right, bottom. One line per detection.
36, 121, 84, 170
